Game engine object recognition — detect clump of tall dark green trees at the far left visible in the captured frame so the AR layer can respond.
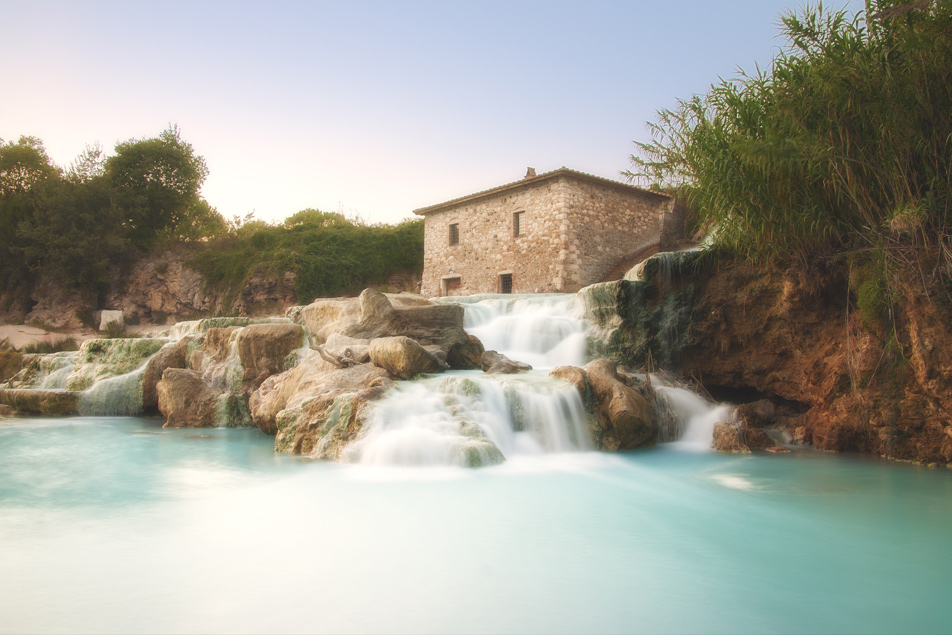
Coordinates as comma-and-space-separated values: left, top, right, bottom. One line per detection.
0, 127, 226, 304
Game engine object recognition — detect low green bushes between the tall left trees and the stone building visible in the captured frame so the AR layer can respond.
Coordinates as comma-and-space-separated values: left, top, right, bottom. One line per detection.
189, 209, 423, 303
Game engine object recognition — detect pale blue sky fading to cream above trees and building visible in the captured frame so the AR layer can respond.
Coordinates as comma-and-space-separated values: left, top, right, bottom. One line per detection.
0, 0, 862, 223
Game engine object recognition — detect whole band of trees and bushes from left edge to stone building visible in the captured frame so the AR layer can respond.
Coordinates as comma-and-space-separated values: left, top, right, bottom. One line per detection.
0, 127, 423, 308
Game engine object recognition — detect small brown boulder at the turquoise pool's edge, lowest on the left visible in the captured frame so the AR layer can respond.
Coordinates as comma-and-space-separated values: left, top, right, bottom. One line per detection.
156, 368, 222, 428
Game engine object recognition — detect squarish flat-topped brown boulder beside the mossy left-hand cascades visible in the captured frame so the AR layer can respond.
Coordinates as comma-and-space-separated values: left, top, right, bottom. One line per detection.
237, 323, 304, 388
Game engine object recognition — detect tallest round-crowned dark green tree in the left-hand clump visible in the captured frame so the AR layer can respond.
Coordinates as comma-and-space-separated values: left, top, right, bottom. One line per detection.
105, 126, 208, 248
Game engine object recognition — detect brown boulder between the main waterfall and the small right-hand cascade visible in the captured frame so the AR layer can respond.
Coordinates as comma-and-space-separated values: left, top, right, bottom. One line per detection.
584, 359, 658, 450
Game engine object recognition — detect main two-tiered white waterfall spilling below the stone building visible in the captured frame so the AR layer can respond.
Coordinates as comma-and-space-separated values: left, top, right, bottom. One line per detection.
345, 295, 592, 465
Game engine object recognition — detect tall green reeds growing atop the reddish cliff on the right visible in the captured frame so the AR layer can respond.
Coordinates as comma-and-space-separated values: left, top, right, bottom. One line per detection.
628, 0, 952, 278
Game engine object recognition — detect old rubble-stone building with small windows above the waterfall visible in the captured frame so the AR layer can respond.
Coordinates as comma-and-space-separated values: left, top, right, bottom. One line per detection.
414, 167, 675, 297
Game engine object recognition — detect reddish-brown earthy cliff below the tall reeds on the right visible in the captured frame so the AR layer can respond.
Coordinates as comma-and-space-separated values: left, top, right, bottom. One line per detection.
582, 257, 952, 464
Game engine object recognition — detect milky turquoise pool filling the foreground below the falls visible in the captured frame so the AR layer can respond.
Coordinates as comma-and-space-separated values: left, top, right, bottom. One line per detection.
0, 418, 952, 633
